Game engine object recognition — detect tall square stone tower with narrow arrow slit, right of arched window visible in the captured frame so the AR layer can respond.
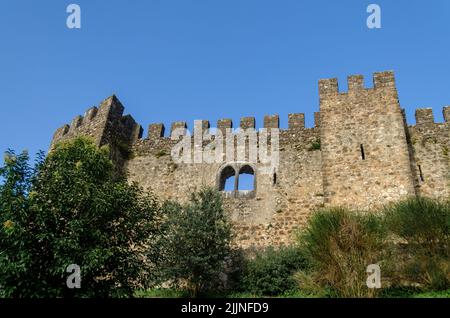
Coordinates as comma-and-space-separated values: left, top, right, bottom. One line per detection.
319, 72, 415, 208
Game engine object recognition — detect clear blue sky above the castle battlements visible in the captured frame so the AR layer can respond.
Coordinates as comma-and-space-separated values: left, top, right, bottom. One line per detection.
0, 0, 450, 161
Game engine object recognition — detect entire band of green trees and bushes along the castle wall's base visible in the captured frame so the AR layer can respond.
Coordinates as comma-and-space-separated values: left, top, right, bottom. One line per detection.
0, 138, 450, 298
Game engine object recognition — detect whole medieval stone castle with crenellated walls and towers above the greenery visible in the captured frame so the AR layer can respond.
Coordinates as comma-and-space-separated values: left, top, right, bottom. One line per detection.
51, 72, 450, 248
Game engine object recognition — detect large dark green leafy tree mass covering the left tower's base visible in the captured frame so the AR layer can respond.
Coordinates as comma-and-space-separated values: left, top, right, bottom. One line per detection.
0, 138, 159, 297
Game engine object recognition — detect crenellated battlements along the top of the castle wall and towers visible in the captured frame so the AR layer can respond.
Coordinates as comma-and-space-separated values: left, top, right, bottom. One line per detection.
52, 71, 450, 145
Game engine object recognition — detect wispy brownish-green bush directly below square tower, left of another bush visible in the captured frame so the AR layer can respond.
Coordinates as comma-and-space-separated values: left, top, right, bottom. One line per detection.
296, 208, 385, 297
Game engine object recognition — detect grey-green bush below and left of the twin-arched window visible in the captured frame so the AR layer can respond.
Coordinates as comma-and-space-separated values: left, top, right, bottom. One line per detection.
157, 188, 232, 297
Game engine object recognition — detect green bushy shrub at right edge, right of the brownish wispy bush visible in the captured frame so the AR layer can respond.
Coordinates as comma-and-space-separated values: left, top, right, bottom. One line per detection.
385, 197, 450, 290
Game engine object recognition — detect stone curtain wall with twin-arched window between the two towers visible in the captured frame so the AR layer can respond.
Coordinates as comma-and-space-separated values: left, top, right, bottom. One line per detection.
126, 114, 323, 247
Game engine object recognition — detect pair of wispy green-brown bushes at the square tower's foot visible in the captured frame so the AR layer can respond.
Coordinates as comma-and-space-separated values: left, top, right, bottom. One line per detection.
295, 197, 450, 297
